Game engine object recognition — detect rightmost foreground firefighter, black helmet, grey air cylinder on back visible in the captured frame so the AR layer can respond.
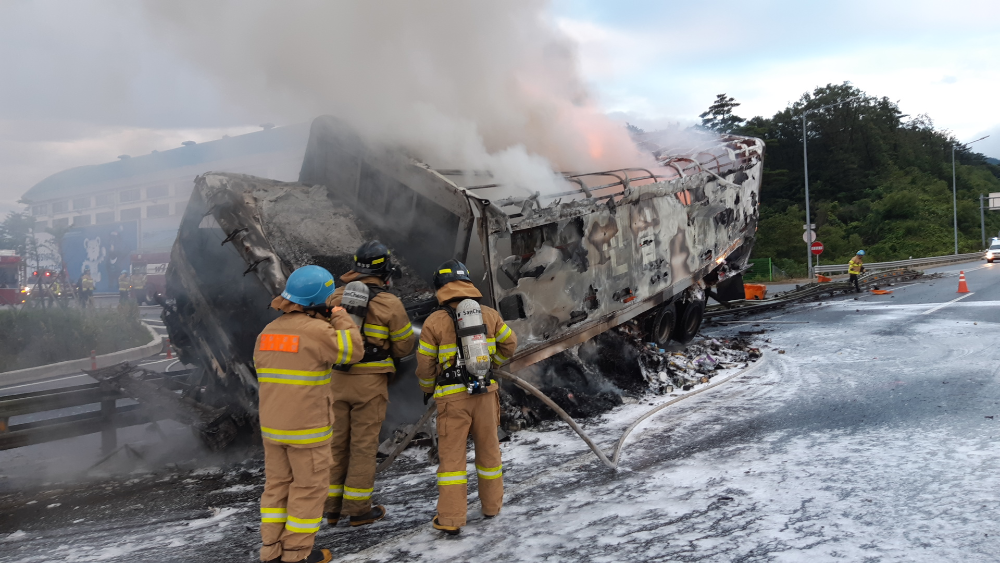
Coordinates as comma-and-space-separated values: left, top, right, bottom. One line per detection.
417, 260, 517, 534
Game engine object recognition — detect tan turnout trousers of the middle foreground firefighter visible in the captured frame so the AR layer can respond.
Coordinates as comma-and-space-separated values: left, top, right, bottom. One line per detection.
325, 371, 389, 516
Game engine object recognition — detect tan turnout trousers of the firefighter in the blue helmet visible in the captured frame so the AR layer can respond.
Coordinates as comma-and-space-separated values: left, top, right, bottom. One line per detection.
260, 440, 330, 561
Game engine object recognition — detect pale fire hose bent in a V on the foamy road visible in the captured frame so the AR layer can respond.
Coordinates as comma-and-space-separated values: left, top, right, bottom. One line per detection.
376, 355, 767, 473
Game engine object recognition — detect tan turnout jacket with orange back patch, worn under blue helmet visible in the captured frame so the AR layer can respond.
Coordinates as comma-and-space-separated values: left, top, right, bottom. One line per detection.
254, 297, 364, 448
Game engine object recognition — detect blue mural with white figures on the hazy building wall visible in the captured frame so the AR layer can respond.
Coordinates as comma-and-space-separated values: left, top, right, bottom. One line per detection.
62, 221, 138, 293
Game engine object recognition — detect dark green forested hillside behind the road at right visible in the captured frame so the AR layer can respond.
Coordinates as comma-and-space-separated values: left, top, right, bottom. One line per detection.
701, 83, 1000, 275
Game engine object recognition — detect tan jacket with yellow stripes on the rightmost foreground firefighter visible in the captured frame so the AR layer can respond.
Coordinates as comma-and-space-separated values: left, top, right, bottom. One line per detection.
416, 282, 517, 400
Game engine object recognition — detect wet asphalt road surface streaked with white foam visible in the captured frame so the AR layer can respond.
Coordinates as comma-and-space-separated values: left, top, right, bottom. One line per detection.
0, 263, 1000, 562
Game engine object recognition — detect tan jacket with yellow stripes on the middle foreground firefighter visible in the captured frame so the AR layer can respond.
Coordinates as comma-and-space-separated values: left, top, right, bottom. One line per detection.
326, 272, 417, 375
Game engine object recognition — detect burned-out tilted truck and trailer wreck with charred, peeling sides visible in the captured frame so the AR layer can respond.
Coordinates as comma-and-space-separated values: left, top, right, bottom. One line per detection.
164, 117, 763, 446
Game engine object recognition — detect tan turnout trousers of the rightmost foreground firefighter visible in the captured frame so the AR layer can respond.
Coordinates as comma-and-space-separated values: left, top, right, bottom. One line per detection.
437, 391, 503, 526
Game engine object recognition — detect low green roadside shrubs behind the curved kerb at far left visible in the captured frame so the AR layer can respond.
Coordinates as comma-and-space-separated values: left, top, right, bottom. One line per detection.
0, 304, 149, 372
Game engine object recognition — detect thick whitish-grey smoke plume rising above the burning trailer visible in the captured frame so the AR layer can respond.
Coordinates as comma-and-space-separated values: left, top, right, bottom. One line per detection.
145, 0, 649, 194
